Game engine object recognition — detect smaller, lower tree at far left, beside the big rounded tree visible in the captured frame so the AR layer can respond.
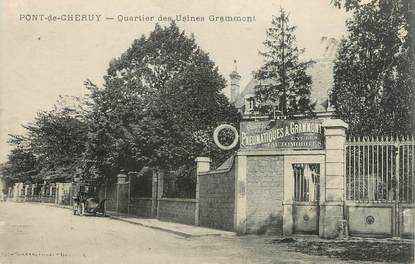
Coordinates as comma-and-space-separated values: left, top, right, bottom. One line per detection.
5, 97, 87, 180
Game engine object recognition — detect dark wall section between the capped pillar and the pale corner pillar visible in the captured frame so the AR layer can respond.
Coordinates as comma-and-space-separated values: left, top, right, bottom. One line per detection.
199, 166, 235, 231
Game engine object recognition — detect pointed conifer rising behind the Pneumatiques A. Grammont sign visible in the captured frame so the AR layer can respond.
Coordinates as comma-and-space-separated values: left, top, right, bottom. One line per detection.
255, 9, 313, 116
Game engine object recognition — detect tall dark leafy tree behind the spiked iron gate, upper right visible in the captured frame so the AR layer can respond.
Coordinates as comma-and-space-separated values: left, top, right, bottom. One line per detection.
331, 0, 414, 135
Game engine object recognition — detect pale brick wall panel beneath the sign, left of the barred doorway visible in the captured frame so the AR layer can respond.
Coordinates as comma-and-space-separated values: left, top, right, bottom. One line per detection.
246, 156, 284, 235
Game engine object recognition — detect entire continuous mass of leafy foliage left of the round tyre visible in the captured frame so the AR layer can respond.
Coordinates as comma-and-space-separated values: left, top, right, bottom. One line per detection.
6, 23, 239, 196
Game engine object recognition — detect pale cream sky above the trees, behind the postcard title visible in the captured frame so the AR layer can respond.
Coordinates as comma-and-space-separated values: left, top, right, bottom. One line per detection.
0, 0, 348, 163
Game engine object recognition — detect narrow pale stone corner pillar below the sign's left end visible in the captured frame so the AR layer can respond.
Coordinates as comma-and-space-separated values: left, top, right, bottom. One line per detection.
234, 155, 247, 235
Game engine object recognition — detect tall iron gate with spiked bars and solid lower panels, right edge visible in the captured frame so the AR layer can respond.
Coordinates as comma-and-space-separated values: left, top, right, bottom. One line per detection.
345, 137, 415, 236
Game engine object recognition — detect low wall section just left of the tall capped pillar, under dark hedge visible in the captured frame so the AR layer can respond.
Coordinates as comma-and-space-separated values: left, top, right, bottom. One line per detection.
157, 198, 196, 225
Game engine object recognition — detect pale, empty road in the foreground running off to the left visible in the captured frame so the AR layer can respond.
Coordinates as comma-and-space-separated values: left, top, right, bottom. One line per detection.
0, 202, 376, 264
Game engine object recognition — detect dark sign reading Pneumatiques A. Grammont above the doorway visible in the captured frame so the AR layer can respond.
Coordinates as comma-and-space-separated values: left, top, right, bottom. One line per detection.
240, 119, 324, 150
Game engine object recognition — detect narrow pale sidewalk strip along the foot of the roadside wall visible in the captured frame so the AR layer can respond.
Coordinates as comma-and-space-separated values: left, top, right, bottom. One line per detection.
107, 211, 235, 237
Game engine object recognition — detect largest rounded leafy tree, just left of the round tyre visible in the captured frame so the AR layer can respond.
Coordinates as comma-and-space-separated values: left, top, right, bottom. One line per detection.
86, 23, 238, 184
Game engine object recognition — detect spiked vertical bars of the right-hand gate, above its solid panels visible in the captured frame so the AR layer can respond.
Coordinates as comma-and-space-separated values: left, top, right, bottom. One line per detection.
345, 137, 415, 203
